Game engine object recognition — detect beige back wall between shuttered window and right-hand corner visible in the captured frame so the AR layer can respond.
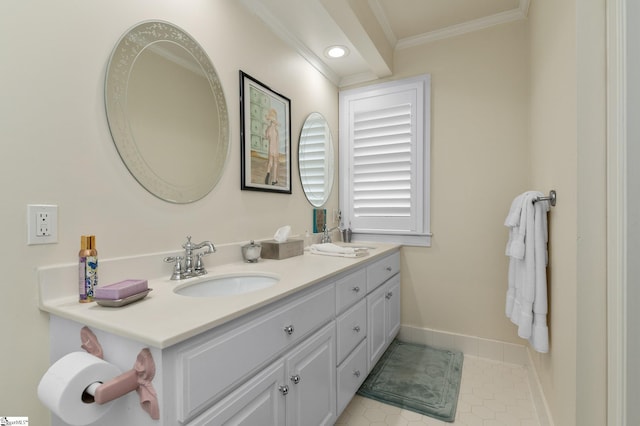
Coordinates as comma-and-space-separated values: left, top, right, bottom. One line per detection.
394, 21, 528, 343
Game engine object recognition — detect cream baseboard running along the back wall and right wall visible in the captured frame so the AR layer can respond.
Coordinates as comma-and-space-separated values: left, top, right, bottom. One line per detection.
398, 325, 554, 426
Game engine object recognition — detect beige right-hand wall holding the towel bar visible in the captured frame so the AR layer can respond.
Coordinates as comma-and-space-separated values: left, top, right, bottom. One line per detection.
529, 0, 607, 426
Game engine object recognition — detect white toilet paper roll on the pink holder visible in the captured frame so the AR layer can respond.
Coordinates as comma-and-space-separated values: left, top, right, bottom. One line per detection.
38, 352, 120, 426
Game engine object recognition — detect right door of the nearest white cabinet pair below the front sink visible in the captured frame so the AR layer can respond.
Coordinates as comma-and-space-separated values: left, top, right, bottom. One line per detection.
286, 321, 337, 426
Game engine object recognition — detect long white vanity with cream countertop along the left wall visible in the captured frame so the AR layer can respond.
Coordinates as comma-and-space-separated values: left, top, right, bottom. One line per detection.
41, 245, 400, 426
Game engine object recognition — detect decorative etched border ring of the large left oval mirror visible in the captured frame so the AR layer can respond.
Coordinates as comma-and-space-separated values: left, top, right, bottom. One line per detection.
105, 20, 230, 204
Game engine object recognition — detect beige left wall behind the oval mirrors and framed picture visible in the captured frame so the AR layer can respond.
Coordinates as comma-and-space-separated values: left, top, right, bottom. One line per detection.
0, 0, 337, 425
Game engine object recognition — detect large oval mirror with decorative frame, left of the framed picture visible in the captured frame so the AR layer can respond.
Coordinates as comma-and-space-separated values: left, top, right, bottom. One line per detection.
105, 21, 229, 203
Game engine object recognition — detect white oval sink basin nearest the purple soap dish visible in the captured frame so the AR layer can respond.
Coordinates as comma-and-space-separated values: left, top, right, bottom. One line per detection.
173, 274, 280, 297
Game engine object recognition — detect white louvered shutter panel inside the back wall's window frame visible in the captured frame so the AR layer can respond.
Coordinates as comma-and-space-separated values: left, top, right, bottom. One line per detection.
350, 90, 422, 233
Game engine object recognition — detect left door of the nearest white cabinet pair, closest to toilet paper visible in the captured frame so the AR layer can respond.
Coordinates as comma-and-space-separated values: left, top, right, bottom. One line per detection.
189, 361, 286, 426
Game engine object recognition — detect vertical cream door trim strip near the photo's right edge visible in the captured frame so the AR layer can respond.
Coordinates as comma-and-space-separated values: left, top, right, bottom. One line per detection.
606, 0, 627, 426
